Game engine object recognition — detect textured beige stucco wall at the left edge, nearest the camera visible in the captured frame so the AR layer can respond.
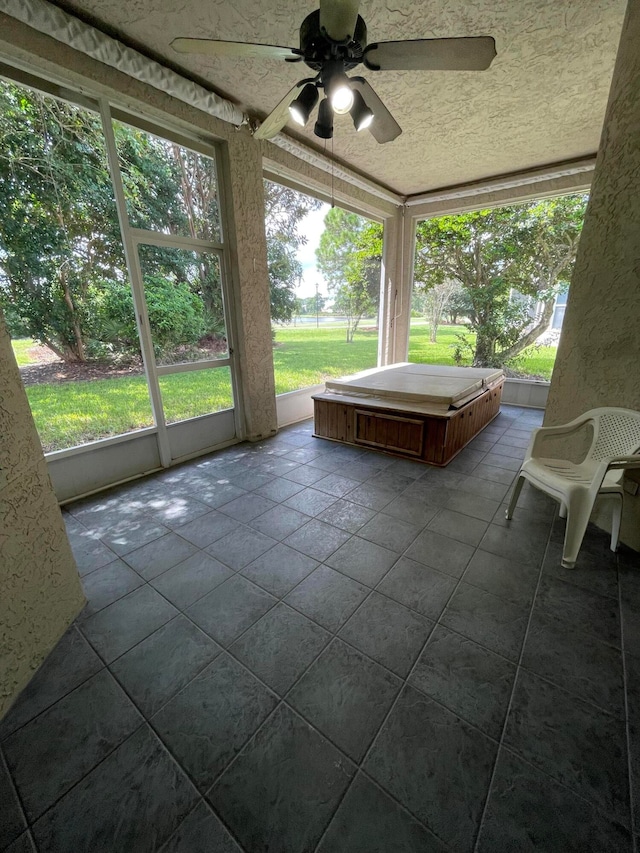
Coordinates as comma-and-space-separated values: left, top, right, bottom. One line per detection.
0, 313, 84, 717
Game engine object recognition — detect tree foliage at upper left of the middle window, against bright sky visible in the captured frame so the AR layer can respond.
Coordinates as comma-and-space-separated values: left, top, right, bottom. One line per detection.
264, 181, 321, 323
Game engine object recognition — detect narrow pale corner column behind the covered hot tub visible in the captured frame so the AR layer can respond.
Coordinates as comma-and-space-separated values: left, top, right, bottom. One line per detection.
378, 207, 413, 365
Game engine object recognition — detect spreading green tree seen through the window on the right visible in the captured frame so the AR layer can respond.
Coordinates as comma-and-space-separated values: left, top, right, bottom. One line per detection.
415, 195, 587, 367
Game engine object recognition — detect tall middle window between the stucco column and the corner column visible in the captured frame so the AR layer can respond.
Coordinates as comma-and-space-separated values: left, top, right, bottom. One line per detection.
265, 181, 382, 394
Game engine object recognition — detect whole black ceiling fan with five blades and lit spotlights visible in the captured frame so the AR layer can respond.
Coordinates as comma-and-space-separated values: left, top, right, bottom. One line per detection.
171, 0, 496, 143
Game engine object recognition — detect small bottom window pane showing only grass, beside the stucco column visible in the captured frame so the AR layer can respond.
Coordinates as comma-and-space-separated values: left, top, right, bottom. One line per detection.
159, 367, 233, 424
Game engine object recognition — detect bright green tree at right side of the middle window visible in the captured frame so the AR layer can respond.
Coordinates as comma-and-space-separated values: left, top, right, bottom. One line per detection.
316, 207, 382, 343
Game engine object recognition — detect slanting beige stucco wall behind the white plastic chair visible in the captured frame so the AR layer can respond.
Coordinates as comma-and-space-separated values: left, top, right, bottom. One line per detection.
545, 0, 640, 549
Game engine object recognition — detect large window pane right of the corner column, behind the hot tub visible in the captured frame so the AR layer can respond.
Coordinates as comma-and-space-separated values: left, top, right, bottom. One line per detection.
409, 195, 587, 380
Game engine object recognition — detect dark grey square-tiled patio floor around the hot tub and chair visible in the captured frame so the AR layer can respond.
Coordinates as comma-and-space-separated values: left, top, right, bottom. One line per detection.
0, 406, 640, 853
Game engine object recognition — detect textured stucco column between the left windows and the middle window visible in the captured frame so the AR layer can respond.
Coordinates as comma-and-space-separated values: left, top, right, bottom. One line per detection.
222, 131, 277, 441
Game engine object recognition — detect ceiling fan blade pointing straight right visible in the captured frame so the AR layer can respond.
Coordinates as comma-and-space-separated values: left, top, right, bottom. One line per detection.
362, 36, 496, 71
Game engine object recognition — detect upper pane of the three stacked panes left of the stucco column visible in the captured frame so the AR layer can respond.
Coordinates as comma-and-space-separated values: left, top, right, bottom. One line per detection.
113, 121, 221, 242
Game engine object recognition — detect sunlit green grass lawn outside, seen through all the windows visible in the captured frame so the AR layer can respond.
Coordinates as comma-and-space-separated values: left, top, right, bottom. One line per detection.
13, 321, 556, 451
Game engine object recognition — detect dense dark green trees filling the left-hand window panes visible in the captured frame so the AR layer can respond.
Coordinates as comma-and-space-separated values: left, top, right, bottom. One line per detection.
0, 84, 222, 361
